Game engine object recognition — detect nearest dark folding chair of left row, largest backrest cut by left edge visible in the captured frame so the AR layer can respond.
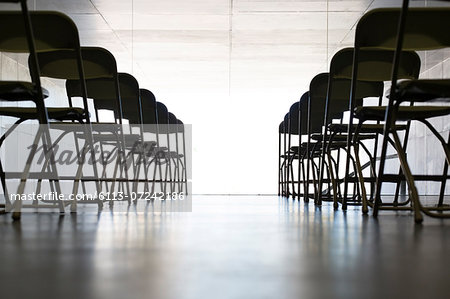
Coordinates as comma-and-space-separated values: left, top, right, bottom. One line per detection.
0, 6, 94, 219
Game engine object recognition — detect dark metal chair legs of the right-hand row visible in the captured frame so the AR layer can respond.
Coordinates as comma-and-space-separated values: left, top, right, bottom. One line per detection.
278, 120, 450, 223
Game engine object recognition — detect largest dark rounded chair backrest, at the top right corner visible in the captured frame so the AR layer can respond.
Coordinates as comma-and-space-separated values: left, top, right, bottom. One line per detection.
355, 7, 450, 50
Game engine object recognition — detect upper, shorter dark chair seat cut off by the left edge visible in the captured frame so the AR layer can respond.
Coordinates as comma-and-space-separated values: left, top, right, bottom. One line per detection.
0, 81, 49, 101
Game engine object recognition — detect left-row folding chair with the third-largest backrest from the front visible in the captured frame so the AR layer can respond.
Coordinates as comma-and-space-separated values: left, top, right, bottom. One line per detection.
66, 71, 141, 205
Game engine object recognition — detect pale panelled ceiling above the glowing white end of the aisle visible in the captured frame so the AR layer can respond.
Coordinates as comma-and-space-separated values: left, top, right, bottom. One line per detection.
14, 0, 442, 95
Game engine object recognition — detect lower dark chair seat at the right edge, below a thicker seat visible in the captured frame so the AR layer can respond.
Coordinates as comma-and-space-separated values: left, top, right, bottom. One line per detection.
355, 106, 450, 121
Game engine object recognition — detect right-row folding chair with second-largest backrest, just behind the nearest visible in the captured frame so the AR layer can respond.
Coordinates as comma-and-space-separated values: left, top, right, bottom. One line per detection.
319, 48, 420, 213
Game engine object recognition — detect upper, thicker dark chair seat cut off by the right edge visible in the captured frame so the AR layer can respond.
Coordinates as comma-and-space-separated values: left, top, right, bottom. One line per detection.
395, 79, 450, 102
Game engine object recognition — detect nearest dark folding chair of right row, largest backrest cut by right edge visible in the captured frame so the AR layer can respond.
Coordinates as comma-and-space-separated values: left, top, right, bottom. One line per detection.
353, 0, 450, 223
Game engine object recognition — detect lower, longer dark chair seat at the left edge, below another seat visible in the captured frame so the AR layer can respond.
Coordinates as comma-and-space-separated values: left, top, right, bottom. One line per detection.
0, 107, 85, 121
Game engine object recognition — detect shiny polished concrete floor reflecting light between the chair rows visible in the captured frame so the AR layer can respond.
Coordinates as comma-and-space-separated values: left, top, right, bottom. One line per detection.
0, 196, 450, 299
